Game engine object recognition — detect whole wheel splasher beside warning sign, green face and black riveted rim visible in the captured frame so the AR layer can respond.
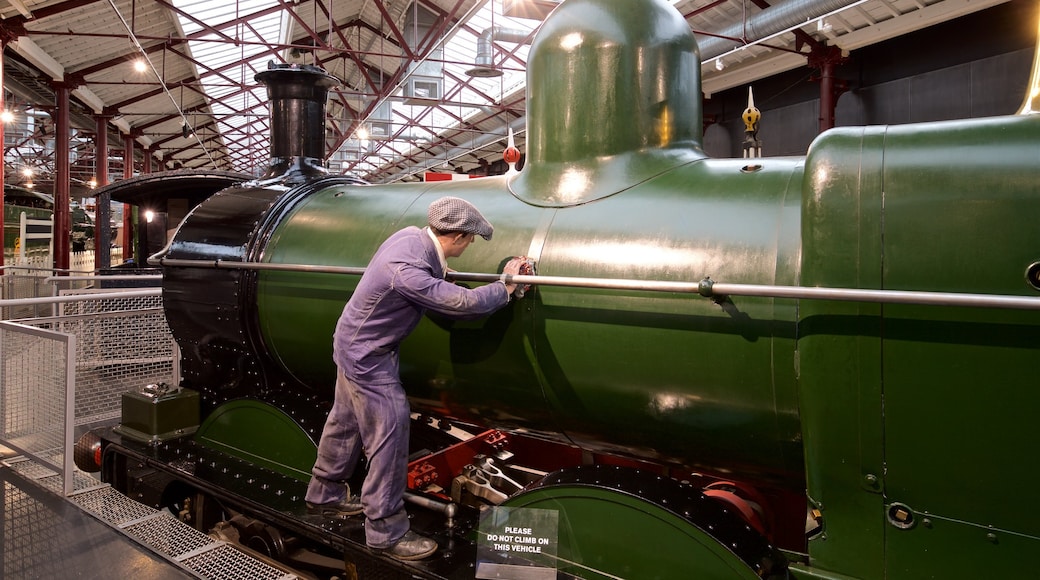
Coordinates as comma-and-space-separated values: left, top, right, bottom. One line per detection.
503, 466, 786, 580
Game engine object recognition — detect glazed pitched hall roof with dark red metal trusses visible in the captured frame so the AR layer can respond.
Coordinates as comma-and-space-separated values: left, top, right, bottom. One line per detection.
0, 0, 1005, 190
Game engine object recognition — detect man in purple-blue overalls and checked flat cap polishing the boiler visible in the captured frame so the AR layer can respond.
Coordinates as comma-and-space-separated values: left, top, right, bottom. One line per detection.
306, 197, 520, 560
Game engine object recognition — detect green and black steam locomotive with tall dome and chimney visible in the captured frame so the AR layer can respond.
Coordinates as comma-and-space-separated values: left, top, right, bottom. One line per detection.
78, 0, 1040, 579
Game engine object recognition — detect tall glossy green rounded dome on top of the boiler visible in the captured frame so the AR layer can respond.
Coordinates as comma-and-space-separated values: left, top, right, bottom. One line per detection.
510, 0, 704, 207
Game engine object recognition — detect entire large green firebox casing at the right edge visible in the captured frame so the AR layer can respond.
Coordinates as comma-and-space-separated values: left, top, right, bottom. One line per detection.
799, 116, 1040, 578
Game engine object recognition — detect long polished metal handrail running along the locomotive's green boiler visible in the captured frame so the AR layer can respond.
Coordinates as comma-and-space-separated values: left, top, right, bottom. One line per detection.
151, 258, 1040, 310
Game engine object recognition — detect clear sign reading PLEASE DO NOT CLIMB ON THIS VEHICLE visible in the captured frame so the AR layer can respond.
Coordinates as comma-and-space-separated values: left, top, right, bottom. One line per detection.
476, 507, 560, 580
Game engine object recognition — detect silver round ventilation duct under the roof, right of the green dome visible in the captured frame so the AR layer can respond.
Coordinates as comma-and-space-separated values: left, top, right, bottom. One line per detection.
697, 0, 863, 62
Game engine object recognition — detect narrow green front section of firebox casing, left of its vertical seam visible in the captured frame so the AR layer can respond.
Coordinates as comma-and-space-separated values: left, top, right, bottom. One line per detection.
798, 125, 884, 578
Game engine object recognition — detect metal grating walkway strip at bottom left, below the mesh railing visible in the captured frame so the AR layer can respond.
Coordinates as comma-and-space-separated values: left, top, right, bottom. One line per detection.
6, 457, 297, 580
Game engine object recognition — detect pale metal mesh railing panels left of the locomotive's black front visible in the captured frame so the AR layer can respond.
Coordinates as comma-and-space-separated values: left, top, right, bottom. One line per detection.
0, 276, 180, 495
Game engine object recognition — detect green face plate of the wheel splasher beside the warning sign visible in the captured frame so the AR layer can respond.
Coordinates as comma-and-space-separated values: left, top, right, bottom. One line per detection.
503, 485, 758, 580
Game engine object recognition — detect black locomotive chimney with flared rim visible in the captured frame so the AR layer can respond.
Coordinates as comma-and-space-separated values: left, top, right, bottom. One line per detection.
255, 62, 340, 183
